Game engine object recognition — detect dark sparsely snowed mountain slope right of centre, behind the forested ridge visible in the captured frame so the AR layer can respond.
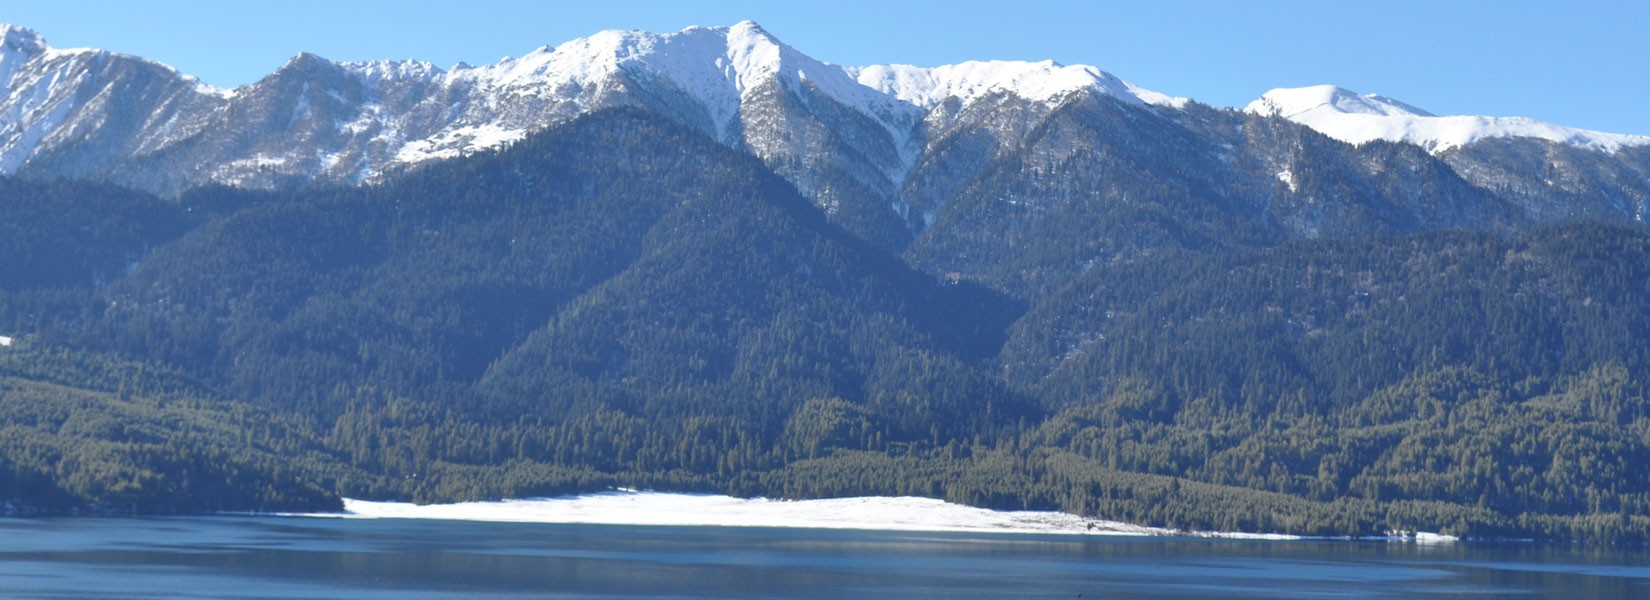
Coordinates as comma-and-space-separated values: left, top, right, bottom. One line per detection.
904, 94, 1530, 303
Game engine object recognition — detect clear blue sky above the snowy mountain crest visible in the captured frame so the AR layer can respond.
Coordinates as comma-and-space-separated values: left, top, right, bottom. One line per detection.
0, 0, 1650, 135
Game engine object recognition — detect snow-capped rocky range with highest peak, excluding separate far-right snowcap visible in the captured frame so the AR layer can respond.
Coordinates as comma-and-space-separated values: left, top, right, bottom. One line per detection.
0, 21, 1185, 246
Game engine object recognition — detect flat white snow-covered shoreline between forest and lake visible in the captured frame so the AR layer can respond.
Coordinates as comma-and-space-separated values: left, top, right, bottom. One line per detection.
292, 490, 1455, 544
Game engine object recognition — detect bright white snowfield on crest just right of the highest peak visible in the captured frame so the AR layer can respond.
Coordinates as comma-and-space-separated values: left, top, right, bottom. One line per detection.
846, 61, 1186, 109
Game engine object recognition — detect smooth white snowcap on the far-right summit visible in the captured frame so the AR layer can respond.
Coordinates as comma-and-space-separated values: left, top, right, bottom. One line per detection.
1244, 86, 1650, 153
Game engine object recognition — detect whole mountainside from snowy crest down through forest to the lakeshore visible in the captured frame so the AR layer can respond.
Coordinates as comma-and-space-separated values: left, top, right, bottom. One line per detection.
0, 21, 1650, 542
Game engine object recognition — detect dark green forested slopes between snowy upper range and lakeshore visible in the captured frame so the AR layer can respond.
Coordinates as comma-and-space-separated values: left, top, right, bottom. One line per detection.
0, 104, 1650, 541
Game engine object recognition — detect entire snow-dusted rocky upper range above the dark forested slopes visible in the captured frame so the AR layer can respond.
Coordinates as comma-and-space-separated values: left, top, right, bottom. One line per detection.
0, 21, 1650, 249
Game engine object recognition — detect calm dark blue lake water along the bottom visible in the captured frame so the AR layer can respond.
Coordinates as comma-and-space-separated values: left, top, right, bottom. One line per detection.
0, 518, 1650, 598
